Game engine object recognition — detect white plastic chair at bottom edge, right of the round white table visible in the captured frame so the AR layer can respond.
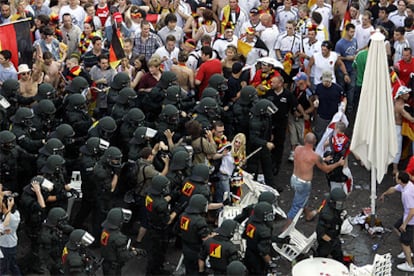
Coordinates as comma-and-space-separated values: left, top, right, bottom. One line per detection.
349, 253, 392, 276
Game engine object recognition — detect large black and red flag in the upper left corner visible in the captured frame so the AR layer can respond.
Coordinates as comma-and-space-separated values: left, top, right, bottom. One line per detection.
0, 19, 33, 68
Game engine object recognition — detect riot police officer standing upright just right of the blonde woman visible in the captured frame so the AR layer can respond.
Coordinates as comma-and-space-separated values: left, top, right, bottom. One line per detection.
247, 99, 277, 190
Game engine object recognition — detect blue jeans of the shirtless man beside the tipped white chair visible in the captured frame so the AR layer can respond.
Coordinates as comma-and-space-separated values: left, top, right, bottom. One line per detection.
287, 174, 312, 219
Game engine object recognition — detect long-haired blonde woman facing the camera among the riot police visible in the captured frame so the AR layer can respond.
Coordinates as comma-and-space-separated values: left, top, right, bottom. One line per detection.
214, 133, 246, 202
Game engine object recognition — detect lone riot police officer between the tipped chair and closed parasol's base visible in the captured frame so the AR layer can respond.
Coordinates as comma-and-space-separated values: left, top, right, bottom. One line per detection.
316, 188, 346, 262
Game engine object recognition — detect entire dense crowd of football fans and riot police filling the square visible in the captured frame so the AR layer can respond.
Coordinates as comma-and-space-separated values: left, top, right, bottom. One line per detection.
0, 0, 414, 275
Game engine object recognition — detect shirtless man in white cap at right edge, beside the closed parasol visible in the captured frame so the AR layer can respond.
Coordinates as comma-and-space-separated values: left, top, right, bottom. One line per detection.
392, 85, 414, 175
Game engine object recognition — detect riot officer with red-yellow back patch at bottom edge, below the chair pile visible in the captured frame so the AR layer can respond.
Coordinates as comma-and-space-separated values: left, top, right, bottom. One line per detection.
198, 220, 240, 275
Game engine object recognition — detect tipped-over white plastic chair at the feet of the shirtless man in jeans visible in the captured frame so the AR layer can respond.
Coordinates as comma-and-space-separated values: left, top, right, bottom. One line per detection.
272, 208, 316, 262
